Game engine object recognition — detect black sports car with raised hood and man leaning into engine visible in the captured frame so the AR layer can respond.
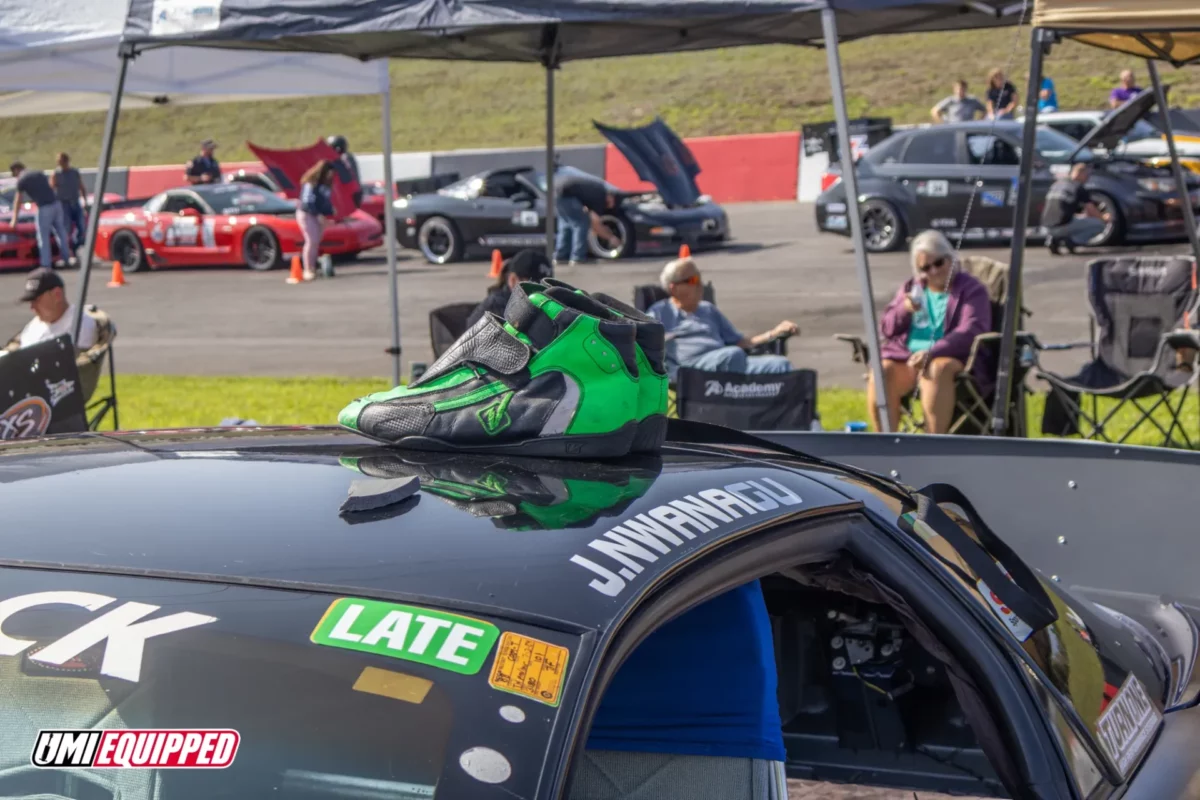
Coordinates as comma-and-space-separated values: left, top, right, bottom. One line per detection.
395, 121, 730, 264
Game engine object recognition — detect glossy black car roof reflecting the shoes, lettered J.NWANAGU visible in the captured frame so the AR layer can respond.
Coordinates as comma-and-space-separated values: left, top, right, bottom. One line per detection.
0, 428, 870, 628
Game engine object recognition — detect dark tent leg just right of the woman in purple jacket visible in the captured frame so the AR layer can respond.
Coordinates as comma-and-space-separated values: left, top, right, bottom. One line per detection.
991, 28, 1050, 437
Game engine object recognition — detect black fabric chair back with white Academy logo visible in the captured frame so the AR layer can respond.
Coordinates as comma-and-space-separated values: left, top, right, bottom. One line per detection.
676, 367, 817, 431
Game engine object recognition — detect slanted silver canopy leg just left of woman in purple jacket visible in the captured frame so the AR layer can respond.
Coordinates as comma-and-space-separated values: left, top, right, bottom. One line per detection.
821, 7, 892, 433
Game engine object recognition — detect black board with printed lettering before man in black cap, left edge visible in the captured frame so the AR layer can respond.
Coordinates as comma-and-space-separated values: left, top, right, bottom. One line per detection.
0, 333, 88, 440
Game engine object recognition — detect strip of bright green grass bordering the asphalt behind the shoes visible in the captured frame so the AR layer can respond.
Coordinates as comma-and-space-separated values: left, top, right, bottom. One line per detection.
105, 375, 1200, 444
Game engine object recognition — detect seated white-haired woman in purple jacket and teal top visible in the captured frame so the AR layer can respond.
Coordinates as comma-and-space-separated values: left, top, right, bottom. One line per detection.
866, 230, 991, 433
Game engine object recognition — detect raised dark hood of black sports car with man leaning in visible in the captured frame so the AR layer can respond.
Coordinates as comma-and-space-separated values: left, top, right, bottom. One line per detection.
592, 119, 700, 206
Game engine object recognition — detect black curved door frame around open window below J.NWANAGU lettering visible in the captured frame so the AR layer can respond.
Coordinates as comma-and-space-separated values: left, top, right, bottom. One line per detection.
539, 503, 1076, 800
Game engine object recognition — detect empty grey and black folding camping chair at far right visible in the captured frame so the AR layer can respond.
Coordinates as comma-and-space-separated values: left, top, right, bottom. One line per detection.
1037, 255, 1200, 447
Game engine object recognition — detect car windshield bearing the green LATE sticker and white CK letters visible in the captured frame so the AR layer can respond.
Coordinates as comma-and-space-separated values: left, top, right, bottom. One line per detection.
0, 570, 576, 800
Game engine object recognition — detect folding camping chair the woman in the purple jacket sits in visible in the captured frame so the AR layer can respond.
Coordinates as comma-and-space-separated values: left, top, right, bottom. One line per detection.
834, 255, 1042, 438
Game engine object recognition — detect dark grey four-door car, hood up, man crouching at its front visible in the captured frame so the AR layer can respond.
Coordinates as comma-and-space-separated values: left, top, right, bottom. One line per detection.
816, 86, 1200, 252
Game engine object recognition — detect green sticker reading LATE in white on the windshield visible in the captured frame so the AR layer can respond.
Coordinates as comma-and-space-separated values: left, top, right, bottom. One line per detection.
310, 597, 499, 675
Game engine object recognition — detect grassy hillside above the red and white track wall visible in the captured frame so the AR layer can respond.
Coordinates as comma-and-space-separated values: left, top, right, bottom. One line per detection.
0, 29, 1200, 167
